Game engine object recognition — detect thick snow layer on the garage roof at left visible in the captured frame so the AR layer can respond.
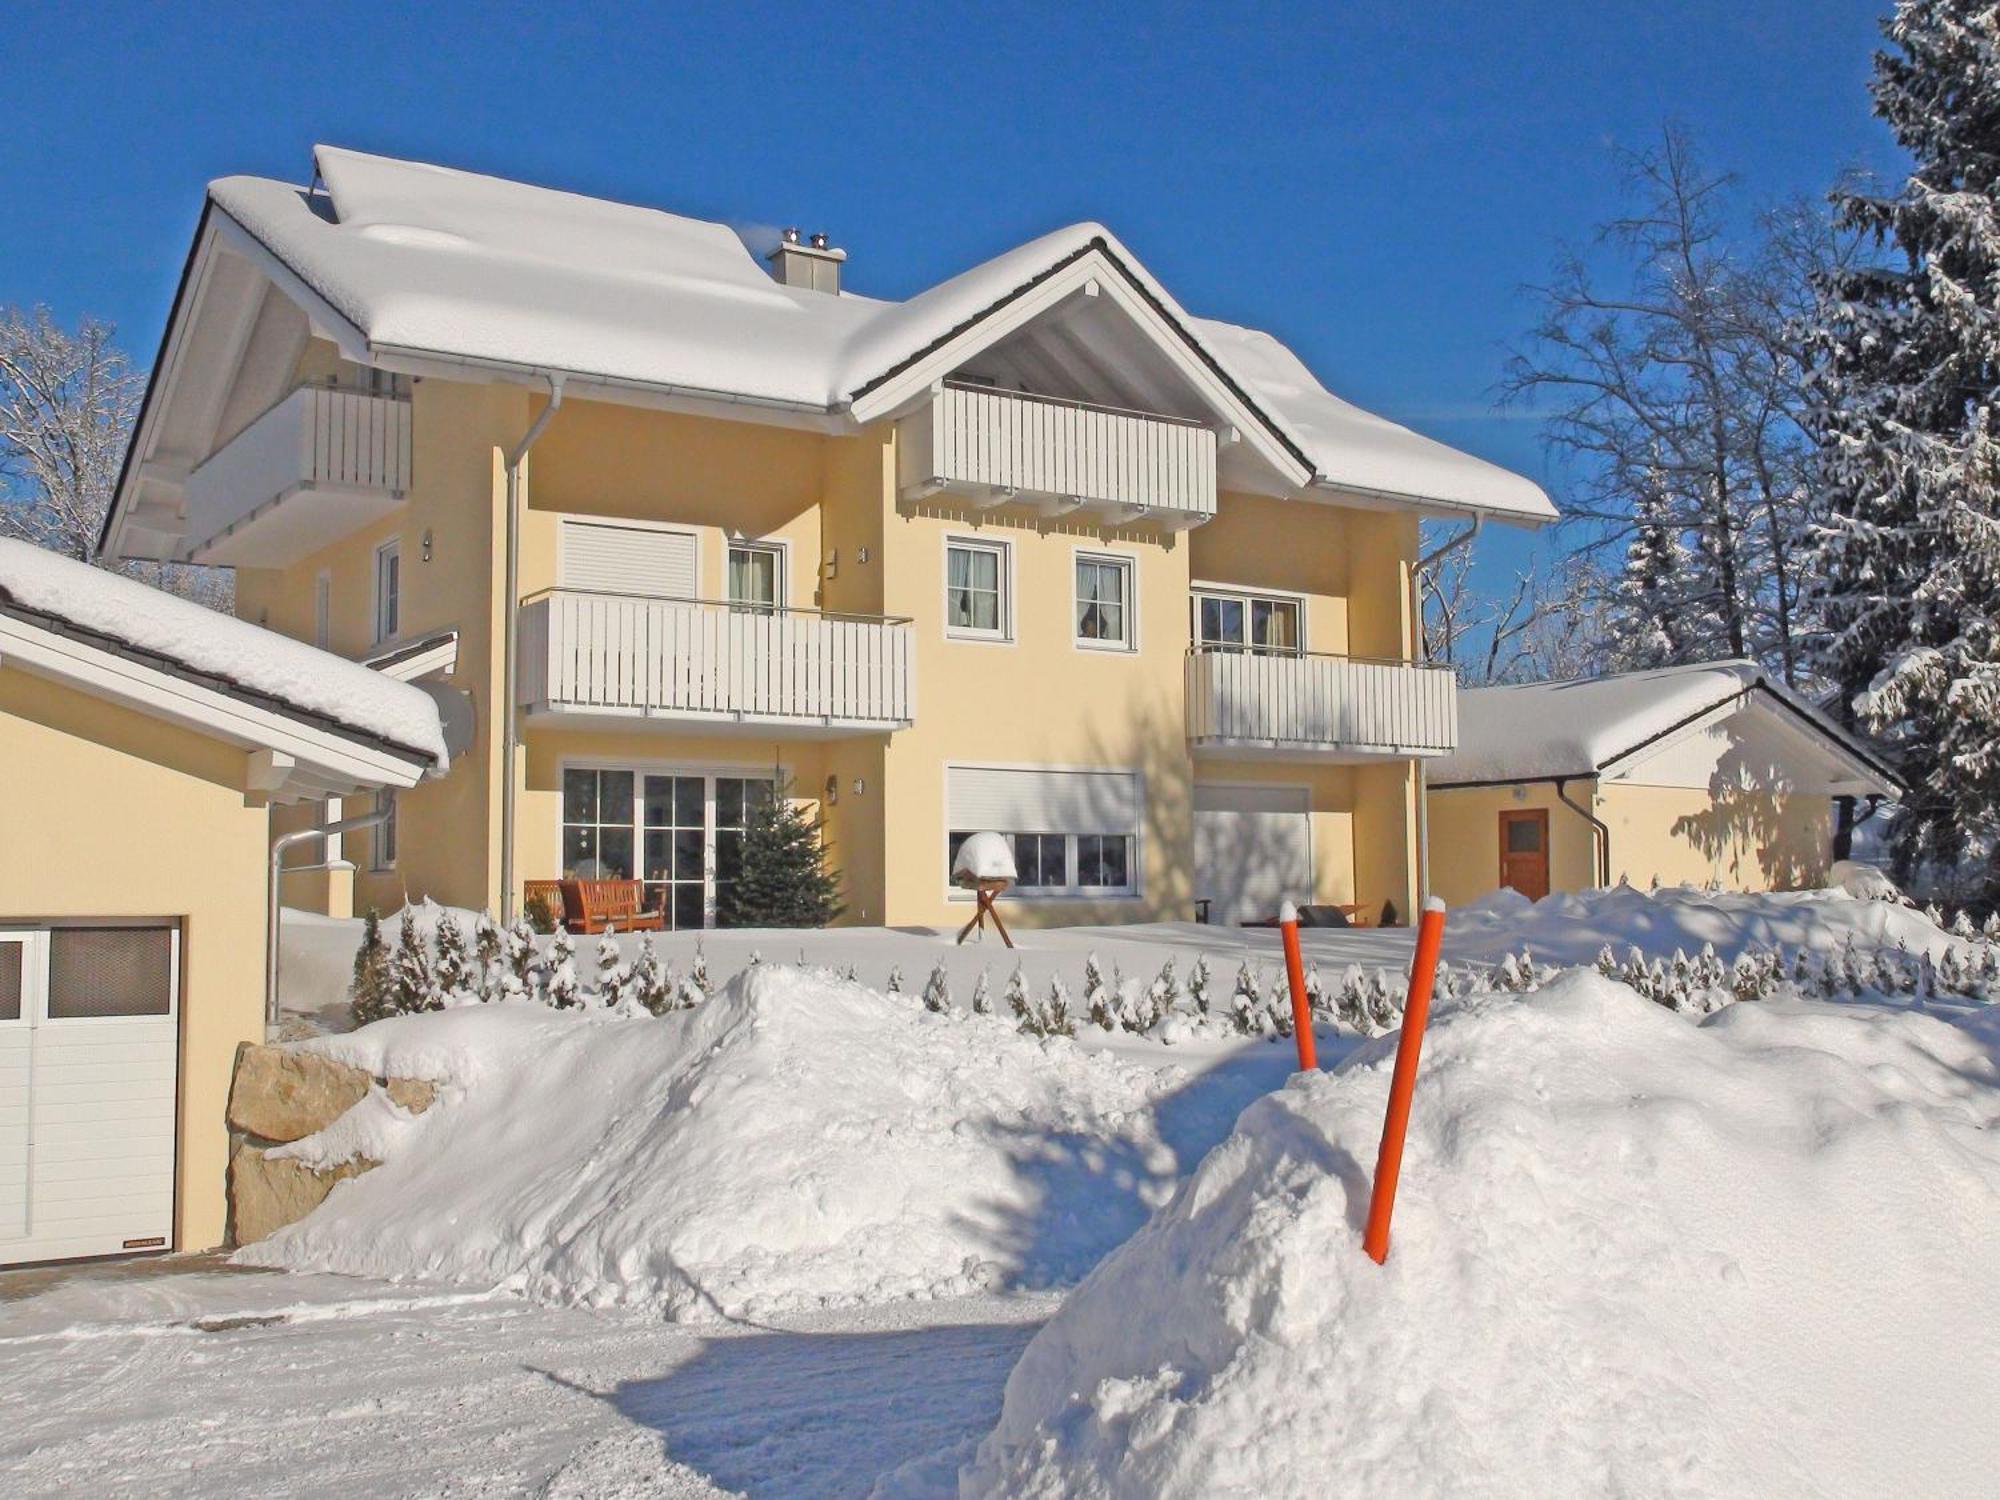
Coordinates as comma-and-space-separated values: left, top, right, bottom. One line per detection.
0, 538, 448, 770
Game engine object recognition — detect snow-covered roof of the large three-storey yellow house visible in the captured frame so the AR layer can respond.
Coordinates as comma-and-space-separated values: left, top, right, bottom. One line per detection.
199, 146, 1556, 522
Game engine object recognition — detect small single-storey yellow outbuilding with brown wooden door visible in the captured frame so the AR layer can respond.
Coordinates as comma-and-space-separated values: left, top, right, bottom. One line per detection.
1426, 662, 1900, 904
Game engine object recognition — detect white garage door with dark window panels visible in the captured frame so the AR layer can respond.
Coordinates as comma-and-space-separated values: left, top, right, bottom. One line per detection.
0, 922, 180, 1264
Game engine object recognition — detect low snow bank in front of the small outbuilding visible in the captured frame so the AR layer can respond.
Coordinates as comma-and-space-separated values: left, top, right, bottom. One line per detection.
1444, 884, 1954, 966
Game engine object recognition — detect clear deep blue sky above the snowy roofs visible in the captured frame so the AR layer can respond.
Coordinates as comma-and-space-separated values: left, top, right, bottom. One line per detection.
0, 0, 1894, 576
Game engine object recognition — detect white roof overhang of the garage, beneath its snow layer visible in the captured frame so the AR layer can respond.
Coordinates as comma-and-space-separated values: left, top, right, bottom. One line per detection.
0, 610, 432, 802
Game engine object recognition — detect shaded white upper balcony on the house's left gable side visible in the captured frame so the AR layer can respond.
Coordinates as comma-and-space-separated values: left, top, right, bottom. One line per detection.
184, 386, 410, 568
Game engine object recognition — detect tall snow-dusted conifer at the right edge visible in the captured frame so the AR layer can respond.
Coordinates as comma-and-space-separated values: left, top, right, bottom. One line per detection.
1814, 0, 2000, 880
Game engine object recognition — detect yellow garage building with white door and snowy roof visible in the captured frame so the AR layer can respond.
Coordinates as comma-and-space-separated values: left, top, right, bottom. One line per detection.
0, 540, 446, 1266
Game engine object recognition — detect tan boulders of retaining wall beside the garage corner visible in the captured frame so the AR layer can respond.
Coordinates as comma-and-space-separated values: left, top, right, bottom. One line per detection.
228, 1042, 436, 1244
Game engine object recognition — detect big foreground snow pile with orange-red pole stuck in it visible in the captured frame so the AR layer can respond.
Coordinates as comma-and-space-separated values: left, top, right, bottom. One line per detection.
960, 974, 2000, 1496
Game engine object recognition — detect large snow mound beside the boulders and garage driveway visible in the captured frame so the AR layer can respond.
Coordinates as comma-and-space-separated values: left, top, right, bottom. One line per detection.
240, 964, 1184, 1318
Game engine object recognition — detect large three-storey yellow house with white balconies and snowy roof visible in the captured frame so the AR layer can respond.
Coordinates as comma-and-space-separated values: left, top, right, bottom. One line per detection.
104, 148, 1552, 926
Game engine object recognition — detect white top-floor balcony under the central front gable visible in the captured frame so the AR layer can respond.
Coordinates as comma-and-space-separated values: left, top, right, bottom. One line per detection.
898, 382, 1216, 530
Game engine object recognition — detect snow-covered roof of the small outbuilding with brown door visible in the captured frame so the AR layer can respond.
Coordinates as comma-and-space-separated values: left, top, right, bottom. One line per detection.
1428, 660, 1894, 786
